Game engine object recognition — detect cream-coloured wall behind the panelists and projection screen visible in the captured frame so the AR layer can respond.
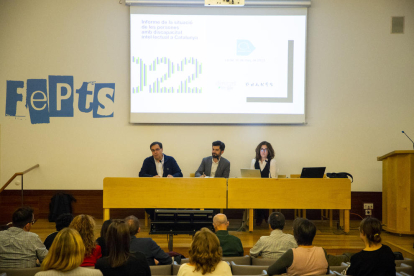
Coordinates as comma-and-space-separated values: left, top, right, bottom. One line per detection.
0, 0, 414, 191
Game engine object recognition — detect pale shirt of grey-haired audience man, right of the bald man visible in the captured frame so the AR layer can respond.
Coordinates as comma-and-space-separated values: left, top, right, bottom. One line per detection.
250, 229, 298, 260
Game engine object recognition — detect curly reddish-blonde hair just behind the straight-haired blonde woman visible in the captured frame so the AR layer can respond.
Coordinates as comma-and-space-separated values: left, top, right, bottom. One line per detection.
69, 215, 96, 256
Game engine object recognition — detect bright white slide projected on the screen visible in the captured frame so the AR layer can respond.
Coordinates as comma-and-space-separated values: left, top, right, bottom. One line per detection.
130, 14, 306, 123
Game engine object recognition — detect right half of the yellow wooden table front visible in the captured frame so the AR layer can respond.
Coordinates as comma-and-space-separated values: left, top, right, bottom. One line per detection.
228, 178, 351, 210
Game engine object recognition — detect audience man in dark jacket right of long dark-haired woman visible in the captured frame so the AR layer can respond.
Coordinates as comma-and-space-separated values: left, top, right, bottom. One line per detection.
125, 216, 172, 265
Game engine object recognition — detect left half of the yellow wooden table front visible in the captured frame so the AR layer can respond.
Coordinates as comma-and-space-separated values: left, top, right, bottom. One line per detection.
103, 177, 227, 209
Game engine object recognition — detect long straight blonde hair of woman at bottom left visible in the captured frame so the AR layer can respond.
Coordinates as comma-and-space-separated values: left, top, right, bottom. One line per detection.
42, 228, 85, 271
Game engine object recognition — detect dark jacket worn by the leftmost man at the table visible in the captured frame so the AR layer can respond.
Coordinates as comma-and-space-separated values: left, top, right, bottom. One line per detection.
139, 154, 183, 177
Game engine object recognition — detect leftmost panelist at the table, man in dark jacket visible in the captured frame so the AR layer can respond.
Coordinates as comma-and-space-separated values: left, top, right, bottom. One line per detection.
139, 142, 183, 177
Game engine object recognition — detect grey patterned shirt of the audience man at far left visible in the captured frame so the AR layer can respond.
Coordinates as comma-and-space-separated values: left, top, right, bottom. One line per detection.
0, 227, 48, 268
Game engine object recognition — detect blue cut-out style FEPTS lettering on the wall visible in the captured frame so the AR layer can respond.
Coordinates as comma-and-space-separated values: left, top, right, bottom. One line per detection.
6, 76, 115, 124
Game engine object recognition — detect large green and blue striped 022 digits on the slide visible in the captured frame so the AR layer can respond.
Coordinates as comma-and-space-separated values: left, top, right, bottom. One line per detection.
132, 56, 203, 94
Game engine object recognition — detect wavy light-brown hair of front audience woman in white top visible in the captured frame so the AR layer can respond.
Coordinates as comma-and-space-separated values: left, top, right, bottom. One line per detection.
189, 228, 222, 275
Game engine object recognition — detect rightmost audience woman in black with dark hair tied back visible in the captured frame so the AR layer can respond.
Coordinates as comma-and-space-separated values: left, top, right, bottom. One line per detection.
346, 218, 395, 276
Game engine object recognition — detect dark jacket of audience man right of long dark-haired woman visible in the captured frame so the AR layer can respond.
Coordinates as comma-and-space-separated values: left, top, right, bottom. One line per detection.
130, 236, 172, 265
